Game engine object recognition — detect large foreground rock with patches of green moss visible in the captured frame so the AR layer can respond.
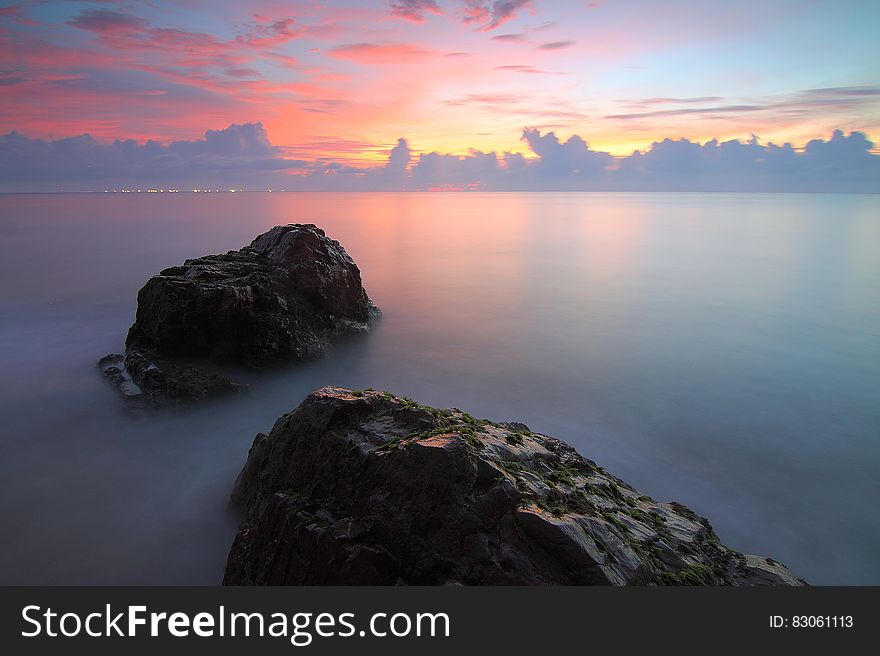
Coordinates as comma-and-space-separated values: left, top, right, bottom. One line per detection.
224, 387, 803, 585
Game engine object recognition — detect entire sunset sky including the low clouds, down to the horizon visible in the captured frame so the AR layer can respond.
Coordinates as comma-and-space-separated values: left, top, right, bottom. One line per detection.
0, 0, 880, 191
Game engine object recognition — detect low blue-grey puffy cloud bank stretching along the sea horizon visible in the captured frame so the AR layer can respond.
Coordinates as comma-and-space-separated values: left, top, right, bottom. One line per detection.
0, 123, 880, 193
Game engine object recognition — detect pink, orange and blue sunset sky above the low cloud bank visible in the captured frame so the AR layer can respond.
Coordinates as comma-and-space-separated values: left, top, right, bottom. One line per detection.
0, 0, 880, 165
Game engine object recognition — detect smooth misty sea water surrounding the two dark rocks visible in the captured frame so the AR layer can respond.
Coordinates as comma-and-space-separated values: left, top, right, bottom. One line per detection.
0, 193, 880, 584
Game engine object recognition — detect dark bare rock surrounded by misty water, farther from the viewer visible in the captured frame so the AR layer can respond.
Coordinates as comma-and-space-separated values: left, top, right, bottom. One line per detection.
99, 224, 378, 405
